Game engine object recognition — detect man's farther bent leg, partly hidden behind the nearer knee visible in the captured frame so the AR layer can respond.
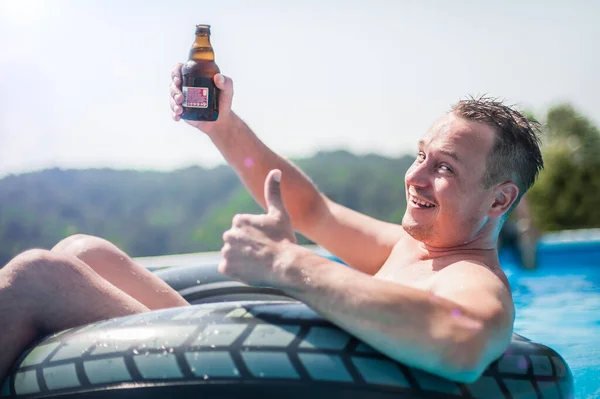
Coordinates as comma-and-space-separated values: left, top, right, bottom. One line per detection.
52, 234, 189, 310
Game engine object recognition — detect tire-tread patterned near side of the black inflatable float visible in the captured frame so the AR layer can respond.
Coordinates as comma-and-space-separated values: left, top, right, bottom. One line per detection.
0, 301, 572, 399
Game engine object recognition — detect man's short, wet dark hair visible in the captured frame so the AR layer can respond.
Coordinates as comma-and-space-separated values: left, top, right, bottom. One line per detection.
451, 96, 544, 205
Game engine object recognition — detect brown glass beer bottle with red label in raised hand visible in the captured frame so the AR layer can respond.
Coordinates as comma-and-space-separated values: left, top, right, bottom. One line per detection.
181, 25, 220, 121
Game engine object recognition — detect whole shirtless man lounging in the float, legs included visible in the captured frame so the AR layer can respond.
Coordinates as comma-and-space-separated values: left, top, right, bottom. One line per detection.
0, 64, 542, 382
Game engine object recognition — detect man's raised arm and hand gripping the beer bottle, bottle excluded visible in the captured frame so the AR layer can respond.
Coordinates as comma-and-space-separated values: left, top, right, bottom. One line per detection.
170, 68, 402, 274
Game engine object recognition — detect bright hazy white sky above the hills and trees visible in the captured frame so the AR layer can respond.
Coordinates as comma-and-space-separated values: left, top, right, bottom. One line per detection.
0, 0, 600, 178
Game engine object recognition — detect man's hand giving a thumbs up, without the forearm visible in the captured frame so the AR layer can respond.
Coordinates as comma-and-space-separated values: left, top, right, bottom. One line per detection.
219, 169, 296, 288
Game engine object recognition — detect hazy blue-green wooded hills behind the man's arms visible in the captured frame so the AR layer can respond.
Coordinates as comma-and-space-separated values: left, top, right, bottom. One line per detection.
0, 151, 412, 267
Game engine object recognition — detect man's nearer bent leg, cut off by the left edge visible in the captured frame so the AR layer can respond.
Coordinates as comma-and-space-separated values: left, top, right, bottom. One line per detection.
0, 249, 149, 381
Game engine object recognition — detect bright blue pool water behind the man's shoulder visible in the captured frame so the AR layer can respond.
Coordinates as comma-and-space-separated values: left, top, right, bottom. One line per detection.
501, 241, 600, 399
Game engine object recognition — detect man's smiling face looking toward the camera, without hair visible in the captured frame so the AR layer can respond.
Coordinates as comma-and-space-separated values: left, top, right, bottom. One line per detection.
402, 113, 495, 248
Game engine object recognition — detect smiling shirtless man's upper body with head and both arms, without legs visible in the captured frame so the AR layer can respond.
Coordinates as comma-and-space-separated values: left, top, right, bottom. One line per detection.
171, 65, 543, 382
